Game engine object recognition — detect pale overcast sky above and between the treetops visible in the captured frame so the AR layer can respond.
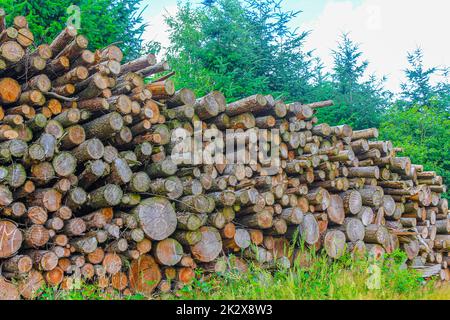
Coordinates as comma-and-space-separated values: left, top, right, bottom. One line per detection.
139, 0, 450, 91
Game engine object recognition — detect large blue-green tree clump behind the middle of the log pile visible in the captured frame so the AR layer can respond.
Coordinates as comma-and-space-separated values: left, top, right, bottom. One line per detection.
166, 0, 312, 100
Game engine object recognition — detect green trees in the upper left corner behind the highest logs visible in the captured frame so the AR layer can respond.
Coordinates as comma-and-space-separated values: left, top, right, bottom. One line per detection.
0, 0, 149, 59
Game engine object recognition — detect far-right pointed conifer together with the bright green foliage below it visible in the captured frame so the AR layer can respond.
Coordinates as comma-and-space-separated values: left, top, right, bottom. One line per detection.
381, 48, 450, 197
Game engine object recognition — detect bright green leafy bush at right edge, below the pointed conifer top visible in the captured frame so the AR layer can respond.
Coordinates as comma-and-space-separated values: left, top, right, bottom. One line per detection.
381, 105, 450, 197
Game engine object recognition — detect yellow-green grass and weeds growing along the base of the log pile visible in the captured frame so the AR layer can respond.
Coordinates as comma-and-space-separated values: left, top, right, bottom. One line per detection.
40, 251, 450, 300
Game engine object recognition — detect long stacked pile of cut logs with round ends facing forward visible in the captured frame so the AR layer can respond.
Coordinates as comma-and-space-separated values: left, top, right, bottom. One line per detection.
0, 10, 450, 299
